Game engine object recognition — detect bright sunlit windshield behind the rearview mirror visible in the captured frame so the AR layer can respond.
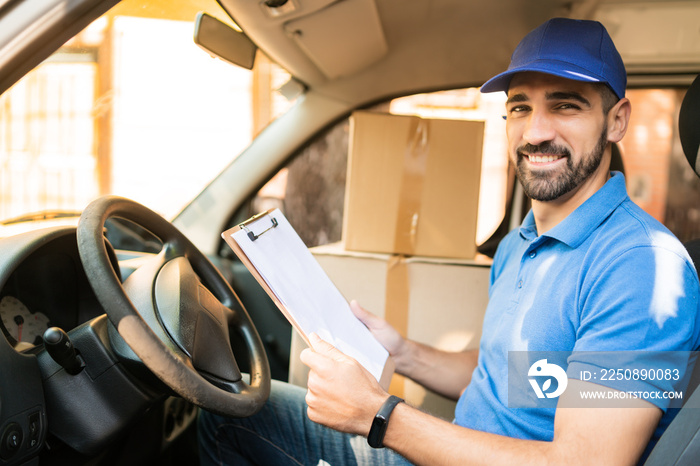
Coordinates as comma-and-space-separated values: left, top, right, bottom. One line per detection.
0, 0, 292, 221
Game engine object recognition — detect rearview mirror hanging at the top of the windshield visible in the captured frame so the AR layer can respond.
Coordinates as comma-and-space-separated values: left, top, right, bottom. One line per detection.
194, 13, 257, 70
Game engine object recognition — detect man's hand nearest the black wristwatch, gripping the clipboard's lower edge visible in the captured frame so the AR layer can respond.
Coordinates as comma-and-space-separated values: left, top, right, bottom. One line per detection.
301, 333, 388, 436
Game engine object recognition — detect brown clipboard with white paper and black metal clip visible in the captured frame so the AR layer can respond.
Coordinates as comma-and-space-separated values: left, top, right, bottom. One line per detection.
221, 209, 394, 389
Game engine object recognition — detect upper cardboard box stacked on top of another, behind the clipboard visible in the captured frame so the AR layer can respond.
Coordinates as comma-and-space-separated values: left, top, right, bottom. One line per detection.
343, 112, 484, 259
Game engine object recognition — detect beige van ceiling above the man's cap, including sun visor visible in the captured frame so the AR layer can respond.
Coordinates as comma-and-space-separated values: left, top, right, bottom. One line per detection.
219, 0, 700, 102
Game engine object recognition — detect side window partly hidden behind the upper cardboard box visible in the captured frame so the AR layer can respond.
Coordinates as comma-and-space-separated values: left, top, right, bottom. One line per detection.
243, 88, 507, 251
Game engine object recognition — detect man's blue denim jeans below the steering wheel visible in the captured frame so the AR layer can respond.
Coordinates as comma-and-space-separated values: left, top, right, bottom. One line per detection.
198, 380, 410, 466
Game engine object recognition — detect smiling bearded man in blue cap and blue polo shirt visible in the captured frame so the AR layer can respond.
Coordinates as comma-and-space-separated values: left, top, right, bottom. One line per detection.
200, 19, 700, 466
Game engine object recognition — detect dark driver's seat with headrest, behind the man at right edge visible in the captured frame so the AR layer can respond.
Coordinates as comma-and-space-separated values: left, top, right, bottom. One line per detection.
644, 76, 700, 466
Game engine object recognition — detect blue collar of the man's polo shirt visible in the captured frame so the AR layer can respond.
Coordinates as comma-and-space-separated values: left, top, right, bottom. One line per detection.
520, 172, 628, 248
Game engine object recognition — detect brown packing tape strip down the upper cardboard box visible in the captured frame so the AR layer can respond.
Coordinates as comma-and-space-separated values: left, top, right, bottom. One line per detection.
394, 118, 430, 255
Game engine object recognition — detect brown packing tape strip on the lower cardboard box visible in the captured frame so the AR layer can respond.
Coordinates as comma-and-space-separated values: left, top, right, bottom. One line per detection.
384, 255, 410, 396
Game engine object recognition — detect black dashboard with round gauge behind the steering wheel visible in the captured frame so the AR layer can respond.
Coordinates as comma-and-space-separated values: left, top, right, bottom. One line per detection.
0, 222, 202, 466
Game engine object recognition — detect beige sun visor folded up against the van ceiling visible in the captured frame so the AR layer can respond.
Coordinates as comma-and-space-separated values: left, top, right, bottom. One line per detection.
284, 0, 388, 79
